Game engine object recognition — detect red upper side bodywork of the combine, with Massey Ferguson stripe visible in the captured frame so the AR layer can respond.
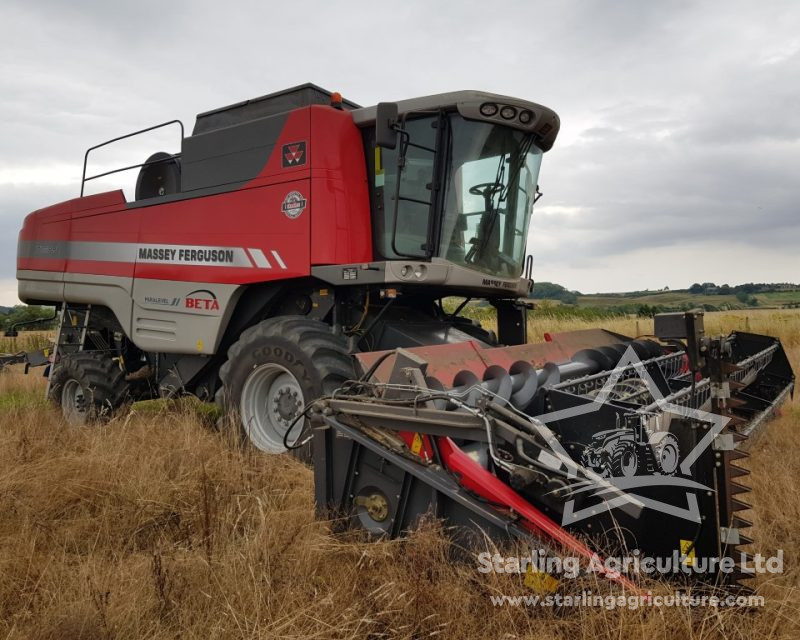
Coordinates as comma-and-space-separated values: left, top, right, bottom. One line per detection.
17, 105, 372, 284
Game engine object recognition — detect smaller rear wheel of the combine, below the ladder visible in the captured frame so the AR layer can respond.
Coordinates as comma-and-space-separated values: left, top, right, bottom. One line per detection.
50, 351, 128, 426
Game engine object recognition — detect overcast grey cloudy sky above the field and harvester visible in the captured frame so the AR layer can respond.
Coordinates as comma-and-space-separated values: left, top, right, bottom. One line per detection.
0, 0, 800, 305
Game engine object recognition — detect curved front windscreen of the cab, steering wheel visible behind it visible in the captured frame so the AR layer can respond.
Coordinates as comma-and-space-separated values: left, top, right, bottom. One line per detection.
439, 114, 542, 278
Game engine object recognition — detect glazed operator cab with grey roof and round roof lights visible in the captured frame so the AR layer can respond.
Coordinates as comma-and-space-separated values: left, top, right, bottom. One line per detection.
353, 91, 559, 288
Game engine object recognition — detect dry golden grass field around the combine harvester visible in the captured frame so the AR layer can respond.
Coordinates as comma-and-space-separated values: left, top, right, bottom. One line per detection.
0, 311, 800, 640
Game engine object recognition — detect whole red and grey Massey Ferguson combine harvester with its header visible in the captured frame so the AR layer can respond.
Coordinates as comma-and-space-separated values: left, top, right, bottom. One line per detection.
17, 85, 793, 585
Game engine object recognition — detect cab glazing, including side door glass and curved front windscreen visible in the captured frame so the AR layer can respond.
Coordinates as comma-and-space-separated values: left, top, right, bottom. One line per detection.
366, 113, 542, 278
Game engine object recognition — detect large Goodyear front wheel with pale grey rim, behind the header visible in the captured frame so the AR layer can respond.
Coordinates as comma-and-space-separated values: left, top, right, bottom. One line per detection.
216, 316, 354, 462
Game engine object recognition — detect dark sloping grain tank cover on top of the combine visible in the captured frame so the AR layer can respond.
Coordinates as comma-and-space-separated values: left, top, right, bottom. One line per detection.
192, 82, 359, 135
